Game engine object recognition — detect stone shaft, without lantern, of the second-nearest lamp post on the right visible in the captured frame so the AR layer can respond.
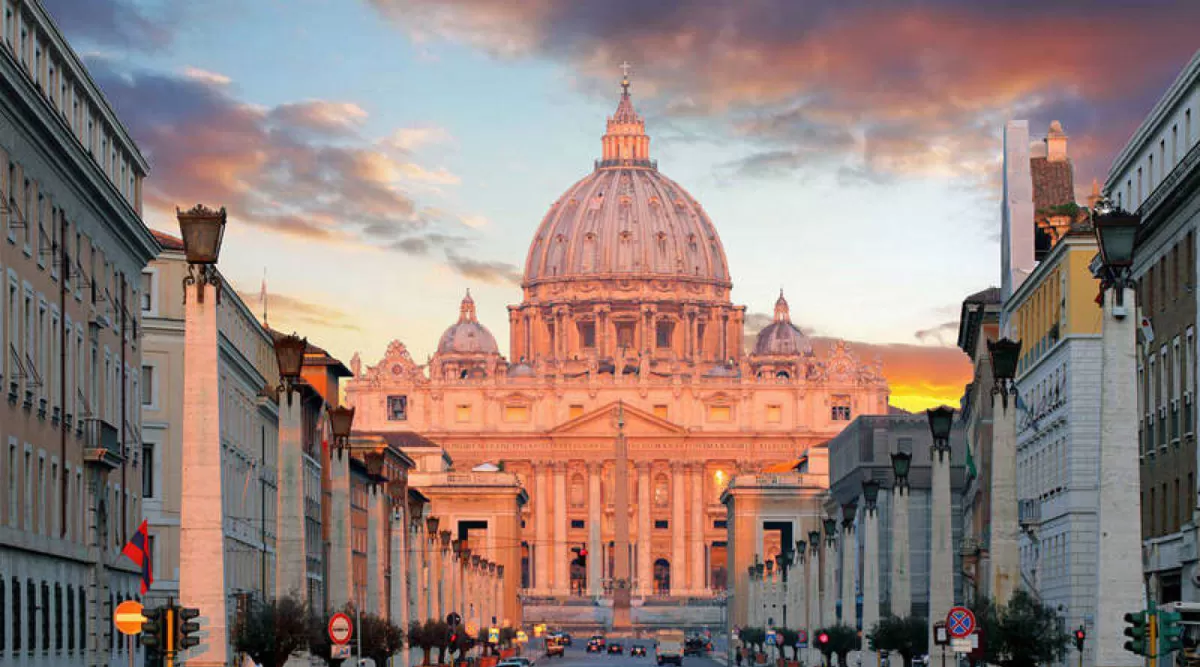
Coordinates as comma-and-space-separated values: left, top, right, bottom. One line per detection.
988, 393, 1017, 606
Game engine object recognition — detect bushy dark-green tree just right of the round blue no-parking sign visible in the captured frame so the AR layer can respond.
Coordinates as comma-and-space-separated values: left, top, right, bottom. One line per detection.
973, 590, 1070, 667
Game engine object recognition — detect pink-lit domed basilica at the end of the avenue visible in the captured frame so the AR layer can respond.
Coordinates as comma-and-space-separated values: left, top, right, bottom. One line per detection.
344, 70, 888, 618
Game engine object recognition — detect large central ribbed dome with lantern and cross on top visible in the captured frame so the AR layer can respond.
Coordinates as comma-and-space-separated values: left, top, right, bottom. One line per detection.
522, 78, 731, 287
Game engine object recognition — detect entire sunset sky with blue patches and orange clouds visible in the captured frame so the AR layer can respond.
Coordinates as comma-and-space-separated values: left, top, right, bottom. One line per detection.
42, 0, 1200, 409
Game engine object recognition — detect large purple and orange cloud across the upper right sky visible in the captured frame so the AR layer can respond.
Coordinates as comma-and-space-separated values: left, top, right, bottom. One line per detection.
371, 0, 1200, 187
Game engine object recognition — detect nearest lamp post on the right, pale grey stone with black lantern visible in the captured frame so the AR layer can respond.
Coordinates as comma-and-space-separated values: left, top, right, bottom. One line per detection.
1092, 202, 1144, 667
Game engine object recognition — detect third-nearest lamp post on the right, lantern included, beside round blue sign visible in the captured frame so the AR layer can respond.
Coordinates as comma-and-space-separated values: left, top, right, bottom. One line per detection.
925, 405, 954, 667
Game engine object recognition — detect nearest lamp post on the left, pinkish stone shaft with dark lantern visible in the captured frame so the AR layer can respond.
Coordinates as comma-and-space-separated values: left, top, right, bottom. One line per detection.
176, 205, 229, 667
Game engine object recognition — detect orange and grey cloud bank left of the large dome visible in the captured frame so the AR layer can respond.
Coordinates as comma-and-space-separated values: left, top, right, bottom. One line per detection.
89, 60, 502, 281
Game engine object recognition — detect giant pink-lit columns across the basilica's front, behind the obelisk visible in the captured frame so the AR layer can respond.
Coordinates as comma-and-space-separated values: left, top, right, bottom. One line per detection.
529, 459, 710, 597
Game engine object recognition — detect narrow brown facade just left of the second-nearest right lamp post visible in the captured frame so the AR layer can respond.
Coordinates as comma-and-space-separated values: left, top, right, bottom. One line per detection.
958, 287, 1000, 603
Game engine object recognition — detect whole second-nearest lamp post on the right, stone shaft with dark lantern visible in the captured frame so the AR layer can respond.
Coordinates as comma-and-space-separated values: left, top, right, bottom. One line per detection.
986, 338, 1021, 606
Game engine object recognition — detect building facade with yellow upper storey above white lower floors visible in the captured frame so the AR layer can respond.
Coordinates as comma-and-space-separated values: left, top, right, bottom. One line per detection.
1003, 223, 1100, 663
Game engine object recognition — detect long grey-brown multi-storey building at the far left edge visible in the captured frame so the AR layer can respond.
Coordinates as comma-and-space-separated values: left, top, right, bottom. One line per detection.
0, 0, 158, 667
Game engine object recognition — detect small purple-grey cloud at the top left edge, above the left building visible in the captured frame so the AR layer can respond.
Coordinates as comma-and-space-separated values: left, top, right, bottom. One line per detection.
42, 0, 175, 53
